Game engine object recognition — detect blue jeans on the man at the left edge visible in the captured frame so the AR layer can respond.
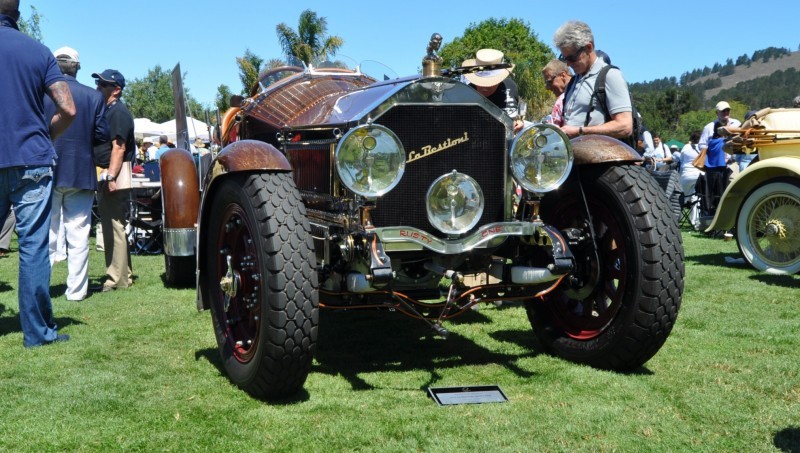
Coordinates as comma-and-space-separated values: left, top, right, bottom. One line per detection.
0, 166, 58, 348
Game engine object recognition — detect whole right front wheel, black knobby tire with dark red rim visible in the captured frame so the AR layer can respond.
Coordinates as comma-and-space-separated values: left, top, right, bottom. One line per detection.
527, 165, 684, 371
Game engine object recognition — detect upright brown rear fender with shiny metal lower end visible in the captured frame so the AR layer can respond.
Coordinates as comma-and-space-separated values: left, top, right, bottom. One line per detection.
159, 148, 200, 256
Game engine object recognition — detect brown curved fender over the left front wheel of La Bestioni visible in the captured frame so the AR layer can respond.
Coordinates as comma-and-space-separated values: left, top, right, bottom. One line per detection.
197, 140, 292, 310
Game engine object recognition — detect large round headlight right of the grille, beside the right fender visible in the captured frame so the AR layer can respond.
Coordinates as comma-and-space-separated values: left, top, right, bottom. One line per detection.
511, 124, 573, 193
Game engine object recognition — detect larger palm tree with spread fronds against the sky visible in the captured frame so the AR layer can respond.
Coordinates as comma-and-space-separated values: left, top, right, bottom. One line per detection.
275, 9, 344, 66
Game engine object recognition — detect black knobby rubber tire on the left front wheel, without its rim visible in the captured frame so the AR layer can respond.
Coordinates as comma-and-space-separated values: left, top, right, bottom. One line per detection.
209, 173, 319, 399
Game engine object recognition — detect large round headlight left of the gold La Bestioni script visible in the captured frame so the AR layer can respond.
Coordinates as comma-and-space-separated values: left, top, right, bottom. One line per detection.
336, 124, 406, 198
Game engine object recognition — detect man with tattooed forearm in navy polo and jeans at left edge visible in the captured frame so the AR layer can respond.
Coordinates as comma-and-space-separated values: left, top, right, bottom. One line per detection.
0, 0, 75, 347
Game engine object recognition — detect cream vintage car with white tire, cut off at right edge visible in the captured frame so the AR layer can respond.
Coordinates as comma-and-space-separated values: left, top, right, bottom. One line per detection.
707, 108, 800, 274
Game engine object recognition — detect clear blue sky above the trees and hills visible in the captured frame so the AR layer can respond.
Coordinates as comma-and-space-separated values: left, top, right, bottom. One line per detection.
29, 0, 800, 104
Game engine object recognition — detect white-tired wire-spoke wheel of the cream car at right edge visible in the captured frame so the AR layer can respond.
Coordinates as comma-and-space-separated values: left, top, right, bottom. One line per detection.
736, 182, 800, 275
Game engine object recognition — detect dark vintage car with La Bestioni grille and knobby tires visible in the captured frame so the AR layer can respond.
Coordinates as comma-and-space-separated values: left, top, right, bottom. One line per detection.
162, 36, 684, 398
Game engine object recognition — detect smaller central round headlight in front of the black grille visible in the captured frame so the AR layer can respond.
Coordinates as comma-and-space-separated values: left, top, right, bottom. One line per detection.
425, 170, 484, 234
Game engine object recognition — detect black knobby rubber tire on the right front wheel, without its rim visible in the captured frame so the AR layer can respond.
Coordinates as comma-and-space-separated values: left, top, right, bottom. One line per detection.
527, 165, 684, 371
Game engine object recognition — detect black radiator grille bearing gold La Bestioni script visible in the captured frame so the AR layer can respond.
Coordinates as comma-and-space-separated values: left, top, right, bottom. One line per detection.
372, 105, 506, 234
